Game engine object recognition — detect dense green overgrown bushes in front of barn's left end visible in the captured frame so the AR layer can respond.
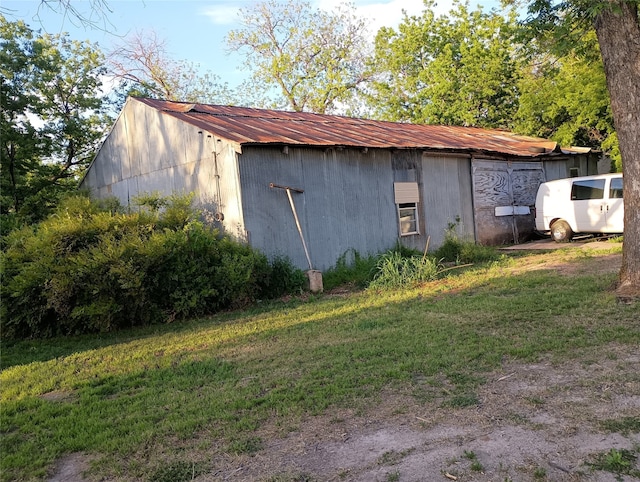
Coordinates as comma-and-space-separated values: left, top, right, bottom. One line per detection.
1, 195, 304, 338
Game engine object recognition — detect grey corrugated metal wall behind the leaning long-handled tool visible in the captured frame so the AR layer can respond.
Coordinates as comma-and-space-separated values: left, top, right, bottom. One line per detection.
239, 147, 398, 270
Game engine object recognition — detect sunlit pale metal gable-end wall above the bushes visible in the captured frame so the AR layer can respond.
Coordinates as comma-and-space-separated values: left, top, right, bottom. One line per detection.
83, 102, 246, 239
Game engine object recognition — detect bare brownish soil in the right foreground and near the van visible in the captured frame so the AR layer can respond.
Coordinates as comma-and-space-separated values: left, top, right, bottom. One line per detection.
50, 245, 640, 482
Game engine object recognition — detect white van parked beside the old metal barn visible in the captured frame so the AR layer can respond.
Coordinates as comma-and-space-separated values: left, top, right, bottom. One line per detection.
535, 173, 624, 243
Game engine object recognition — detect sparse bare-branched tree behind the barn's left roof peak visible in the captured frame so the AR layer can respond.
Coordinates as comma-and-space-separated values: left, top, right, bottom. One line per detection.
108, 31, 234, 104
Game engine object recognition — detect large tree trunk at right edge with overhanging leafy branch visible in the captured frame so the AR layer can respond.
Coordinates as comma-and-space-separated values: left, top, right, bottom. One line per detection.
528, 0, 640, 299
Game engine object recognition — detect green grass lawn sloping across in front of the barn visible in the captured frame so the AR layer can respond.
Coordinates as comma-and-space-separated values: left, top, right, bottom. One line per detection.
0, 247, 640, 481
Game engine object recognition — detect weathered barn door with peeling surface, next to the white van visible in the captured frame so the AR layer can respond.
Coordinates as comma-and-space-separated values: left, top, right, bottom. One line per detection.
472, 159, 545, 245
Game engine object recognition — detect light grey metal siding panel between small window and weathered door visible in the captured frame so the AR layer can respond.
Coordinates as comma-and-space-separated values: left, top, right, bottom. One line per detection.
422, 154, 475, 249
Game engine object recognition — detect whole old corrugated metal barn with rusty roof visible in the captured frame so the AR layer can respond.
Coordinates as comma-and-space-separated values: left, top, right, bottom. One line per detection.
81, 98, 598, 270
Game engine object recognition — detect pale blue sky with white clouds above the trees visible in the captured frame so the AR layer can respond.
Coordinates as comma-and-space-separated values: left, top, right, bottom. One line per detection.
1, 0, 499, 87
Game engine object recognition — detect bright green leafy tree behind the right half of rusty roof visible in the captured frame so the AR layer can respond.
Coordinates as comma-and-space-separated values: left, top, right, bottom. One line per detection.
370, 0, 520, 127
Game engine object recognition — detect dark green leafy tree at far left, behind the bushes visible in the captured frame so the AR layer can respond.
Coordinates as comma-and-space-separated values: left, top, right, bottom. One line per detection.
0, 16, 111, 226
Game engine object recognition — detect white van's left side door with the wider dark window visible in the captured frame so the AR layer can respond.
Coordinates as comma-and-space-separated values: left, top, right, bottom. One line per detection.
571, 179, 607, 233
